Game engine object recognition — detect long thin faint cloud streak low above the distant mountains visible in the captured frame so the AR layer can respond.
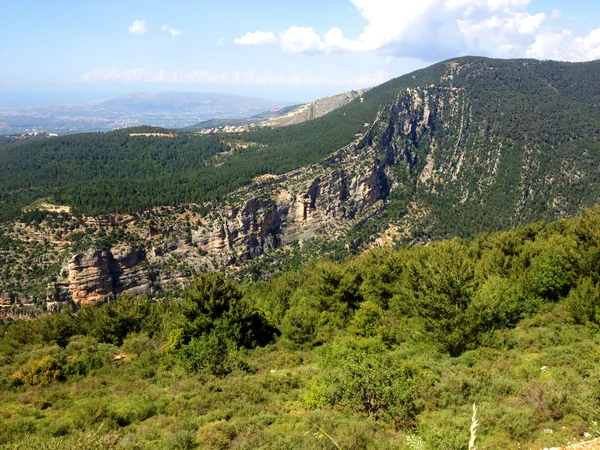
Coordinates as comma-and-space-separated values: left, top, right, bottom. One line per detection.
81, 68, 390, 87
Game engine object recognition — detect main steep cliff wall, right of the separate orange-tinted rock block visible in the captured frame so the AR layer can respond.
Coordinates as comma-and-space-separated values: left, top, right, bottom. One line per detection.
192, 86, 442, 267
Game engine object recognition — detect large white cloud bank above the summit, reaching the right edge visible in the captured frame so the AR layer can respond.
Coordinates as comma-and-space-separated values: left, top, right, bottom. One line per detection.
233, 0, 600, 61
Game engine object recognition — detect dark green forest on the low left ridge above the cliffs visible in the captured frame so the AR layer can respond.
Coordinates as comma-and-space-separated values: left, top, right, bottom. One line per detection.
0, 117, 366, 219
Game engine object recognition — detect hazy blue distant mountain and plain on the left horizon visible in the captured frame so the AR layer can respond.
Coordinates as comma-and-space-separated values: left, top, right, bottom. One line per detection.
0, 92, 290, 134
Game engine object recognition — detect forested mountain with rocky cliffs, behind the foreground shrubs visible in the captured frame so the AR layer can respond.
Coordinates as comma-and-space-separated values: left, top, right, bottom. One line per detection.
0, 57, 600, 304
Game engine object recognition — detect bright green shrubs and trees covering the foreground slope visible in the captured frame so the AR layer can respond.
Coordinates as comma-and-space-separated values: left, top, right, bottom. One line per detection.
0, 208, 600, 450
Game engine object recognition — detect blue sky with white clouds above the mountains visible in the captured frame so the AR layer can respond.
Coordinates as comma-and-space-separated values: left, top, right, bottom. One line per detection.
0, 0, 600, 106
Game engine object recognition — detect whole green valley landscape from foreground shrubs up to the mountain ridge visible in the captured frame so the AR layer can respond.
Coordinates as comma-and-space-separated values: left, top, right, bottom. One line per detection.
0, 57, 600, 450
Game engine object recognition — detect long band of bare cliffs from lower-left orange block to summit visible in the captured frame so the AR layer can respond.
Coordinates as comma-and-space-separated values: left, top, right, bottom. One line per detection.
58, 85, 464, 305
